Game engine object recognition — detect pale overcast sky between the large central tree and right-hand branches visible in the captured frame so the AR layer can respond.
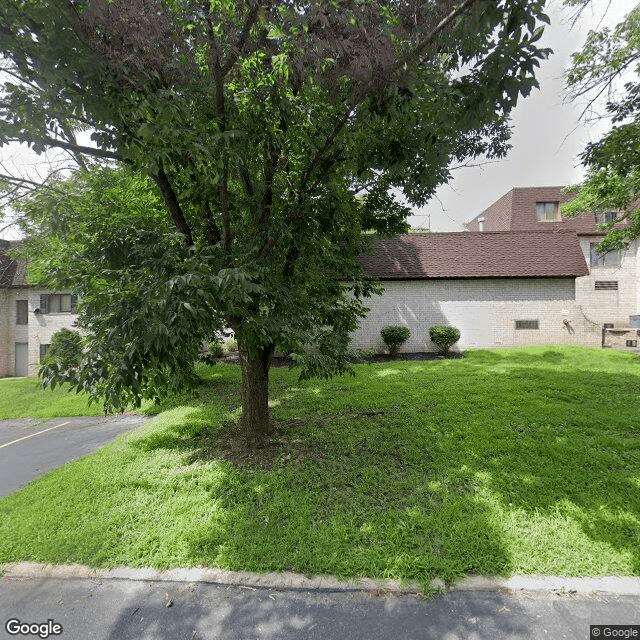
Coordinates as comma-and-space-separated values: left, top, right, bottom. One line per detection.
409, 0, 637, 231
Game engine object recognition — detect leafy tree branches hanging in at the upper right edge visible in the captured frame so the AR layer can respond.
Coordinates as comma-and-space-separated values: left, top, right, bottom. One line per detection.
563, 0, 640, 251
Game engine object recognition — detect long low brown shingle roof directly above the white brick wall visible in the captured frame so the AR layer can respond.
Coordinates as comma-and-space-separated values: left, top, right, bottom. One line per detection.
360, 231, 589, 280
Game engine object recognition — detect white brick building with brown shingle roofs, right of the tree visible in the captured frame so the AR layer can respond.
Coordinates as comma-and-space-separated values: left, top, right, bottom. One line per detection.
353, 187, 640, 351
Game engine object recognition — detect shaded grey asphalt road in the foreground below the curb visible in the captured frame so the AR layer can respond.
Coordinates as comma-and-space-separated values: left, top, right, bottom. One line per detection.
0, 576, 640, 640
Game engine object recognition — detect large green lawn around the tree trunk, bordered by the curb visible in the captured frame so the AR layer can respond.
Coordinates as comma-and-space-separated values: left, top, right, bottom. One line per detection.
0, 347, 640, 584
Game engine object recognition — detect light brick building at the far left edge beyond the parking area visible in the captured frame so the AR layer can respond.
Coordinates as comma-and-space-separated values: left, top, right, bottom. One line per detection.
0, 240, 77, 376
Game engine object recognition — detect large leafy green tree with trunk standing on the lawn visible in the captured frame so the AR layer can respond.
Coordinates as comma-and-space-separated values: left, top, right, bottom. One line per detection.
0, 0, 548, 435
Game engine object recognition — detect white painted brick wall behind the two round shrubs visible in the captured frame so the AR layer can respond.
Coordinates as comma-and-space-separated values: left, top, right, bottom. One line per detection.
352, 278, 601, 352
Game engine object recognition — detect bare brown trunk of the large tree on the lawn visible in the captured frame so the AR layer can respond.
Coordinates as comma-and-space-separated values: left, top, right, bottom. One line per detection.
238, 344, 275, 443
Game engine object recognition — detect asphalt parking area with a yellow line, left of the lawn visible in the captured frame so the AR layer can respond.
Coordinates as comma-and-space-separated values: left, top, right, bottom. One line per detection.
0, 416, 147, 497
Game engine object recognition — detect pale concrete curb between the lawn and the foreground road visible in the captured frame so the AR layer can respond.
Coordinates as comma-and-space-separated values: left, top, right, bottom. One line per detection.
5, 562, 640, 596
